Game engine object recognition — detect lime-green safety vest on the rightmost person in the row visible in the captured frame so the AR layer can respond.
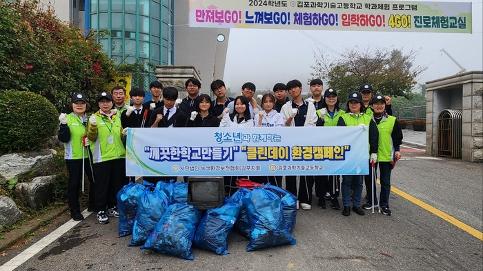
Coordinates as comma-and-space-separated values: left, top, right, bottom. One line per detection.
377, 116, 396, 162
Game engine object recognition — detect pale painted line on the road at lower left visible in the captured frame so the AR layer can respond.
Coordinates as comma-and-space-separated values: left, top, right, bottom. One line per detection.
0, 209, 91, 271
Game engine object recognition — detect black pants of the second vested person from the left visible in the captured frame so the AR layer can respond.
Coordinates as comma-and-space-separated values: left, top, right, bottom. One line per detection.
94, 159, 126, 211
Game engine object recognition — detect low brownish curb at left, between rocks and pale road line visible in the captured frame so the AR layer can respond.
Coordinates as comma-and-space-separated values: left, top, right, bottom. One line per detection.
0, 205, 69, 251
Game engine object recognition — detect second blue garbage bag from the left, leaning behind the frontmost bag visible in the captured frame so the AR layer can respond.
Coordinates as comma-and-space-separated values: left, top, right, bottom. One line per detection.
129, 186, 168, 246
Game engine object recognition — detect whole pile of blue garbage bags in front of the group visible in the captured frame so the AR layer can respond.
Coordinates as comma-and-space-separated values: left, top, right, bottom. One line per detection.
117, 181, 297, 260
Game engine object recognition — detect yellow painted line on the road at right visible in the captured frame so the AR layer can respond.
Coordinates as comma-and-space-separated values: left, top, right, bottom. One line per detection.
392, 186, 483, 241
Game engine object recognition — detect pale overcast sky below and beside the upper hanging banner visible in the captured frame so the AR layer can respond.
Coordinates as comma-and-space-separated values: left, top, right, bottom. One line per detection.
224, 0, 483, 91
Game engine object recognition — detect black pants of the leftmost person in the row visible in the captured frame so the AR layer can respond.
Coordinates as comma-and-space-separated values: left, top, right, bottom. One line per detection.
65, 159, 95, 213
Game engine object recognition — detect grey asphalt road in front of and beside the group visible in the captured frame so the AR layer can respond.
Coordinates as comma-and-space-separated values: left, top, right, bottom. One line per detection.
0, 149, 483, 271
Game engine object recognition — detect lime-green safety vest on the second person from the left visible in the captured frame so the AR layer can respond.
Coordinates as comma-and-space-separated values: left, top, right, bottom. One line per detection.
90, 112, 126, 163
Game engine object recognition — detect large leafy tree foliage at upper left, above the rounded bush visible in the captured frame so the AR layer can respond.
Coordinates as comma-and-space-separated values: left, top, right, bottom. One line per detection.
0, 0, 114, 111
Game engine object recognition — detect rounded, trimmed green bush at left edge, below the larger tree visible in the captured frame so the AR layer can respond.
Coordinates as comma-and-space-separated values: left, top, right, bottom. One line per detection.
0, 90, 58, 153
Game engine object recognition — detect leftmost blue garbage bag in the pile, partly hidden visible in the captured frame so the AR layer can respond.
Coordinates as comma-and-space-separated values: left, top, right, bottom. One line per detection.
117, 183, 145, 237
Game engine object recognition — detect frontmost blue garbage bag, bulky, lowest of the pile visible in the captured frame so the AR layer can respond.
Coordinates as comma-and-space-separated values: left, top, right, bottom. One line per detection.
142, 203, 200, 260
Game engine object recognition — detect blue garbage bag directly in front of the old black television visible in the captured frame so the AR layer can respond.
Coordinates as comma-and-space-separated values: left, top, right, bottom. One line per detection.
193, 201, 241, 255
